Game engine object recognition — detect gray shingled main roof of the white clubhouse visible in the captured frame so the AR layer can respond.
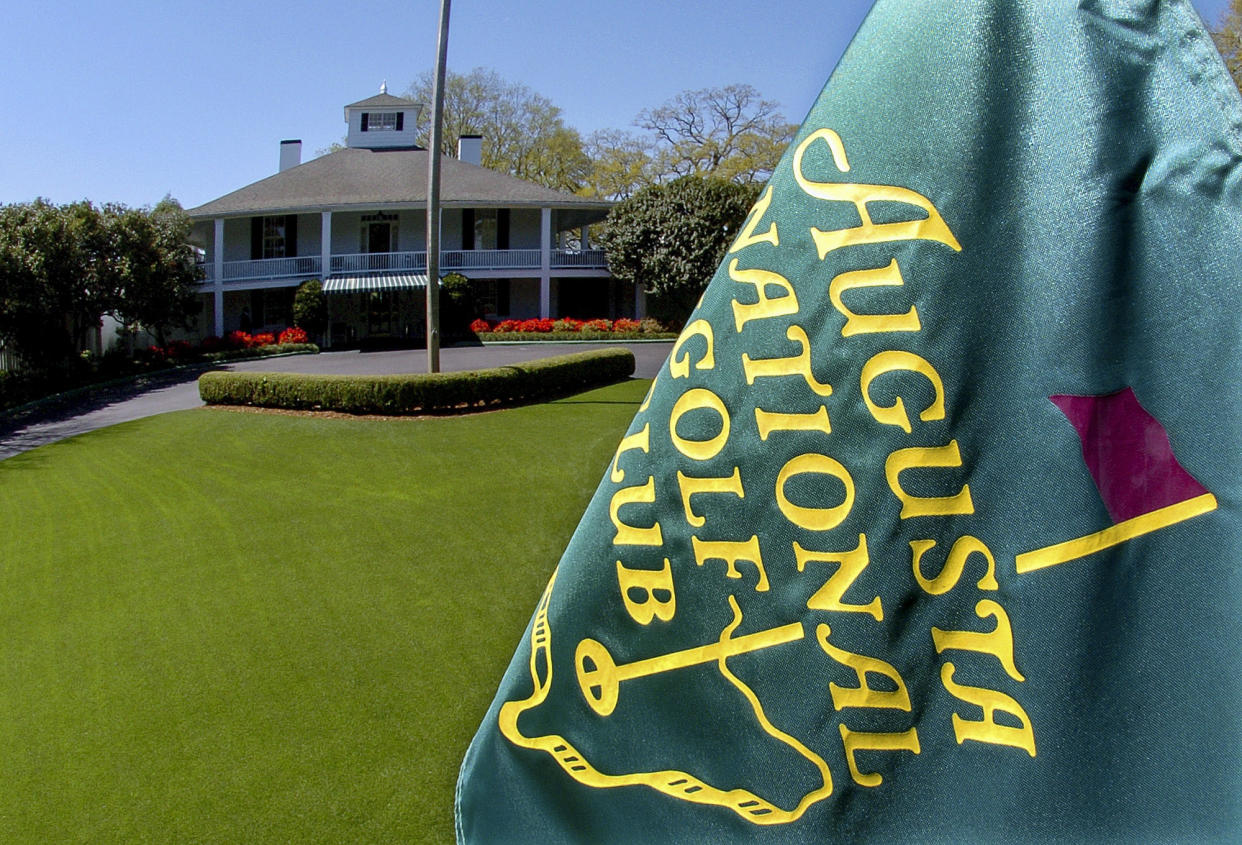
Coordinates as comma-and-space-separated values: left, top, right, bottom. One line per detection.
189, 149, 611, 220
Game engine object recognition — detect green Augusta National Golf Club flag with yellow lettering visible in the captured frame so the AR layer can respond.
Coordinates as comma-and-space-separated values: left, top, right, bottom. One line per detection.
456, 0, 1242, 844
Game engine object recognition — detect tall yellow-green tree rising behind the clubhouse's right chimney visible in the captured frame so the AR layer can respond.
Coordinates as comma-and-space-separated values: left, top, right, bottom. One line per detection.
406, 67, 590, 190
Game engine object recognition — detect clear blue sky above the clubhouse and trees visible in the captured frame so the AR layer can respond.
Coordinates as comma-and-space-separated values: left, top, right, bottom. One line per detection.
0, 0, 1227, 206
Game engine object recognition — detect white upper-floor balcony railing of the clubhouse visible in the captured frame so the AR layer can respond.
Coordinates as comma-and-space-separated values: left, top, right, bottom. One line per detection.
200, 250, 607, 285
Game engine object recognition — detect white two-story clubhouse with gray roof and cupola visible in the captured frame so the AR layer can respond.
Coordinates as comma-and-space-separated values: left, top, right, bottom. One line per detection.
189, 88, 630, 345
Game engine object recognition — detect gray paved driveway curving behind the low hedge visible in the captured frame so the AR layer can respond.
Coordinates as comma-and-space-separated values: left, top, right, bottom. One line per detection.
0, 340, 673, 460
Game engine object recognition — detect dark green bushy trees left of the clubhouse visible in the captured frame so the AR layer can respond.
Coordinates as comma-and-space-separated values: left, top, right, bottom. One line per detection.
0, 199, 199, 369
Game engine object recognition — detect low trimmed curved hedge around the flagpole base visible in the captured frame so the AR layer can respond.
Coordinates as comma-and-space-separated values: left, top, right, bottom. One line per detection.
199, 349, 635, 414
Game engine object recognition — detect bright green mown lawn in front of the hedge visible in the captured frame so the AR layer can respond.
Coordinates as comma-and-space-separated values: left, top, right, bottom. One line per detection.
0, 380, 648, 843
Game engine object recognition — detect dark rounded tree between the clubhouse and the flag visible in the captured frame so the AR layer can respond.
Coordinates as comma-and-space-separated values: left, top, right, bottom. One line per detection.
599, 175, 759, 324
